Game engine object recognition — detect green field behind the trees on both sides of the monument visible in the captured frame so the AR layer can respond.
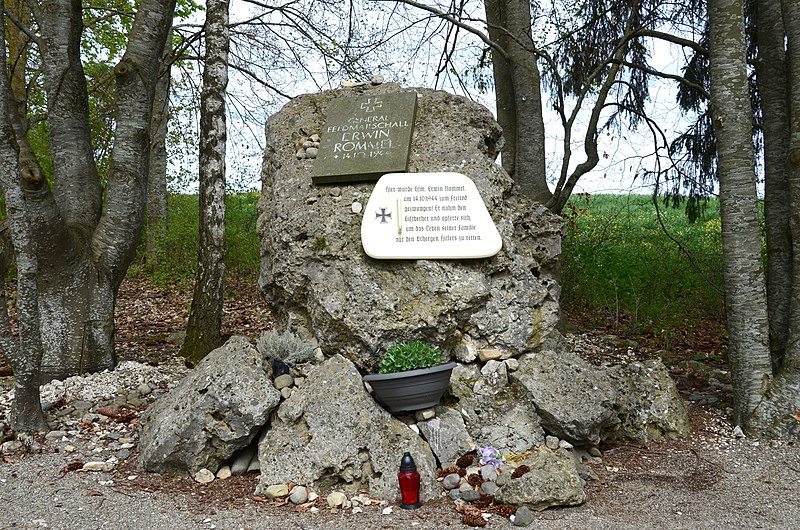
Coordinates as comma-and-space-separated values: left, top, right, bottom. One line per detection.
141, 193, 724, 349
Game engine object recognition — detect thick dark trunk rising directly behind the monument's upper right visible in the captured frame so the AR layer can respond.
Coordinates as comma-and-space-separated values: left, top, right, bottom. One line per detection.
484, 0, 551, 203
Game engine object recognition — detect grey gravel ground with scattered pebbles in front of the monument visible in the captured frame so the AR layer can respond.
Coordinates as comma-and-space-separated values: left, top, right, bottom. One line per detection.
0, 340, 800, 530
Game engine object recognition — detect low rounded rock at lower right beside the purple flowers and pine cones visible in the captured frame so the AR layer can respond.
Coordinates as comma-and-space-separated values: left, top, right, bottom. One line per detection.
495, 448, 586, 510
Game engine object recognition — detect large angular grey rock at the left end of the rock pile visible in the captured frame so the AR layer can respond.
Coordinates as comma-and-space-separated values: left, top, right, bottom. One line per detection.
138, 337, 280, 474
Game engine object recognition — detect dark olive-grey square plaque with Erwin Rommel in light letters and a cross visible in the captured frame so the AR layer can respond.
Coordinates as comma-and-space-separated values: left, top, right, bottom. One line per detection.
312, 92, 417, 184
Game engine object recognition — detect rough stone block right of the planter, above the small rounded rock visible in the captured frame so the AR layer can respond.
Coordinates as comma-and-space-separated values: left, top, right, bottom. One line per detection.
510, 351, 619, 445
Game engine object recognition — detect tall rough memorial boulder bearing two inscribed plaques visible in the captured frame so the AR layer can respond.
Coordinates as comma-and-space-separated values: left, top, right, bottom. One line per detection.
258, 84, 563, 371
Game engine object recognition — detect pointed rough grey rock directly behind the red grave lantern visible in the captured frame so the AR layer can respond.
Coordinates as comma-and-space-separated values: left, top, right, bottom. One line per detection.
256, 355, 439, 500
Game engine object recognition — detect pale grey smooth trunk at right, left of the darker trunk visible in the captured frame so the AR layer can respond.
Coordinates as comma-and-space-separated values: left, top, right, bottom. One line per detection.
708, 0, 772, 427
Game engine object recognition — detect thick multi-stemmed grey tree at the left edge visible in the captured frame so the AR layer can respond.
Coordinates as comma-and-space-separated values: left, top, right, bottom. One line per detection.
0, 0, 175, 430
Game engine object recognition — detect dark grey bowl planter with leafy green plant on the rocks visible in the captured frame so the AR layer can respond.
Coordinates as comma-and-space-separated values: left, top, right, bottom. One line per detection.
364, 340, 456, 412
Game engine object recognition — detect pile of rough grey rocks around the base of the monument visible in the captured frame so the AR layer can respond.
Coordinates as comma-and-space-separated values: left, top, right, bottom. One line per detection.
130, 337, 687, 520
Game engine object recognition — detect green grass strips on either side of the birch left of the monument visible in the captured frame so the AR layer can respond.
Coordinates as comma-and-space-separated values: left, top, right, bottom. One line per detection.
131, 193, 260, 284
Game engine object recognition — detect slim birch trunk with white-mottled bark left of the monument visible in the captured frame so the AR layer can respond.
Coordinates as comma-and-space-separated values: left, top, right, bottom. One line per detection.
180, 0, 229, 363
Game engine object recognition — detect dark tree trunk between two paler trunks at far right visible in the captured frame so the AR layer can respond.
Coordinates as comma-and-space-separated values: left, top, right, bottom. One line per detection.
756, 0, 792, 373
